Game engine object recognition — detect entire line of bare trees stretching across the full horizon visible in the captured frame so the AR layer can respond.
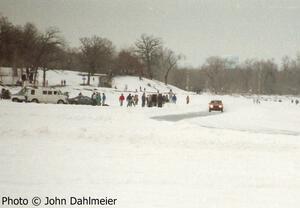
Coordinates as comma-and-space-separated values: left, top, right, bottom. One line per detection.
0, 16, 300, 94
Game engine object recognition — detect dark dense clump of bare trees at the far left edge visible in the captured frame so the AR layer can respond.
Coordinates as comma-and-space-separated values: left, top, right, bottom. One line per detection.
0, 17, 64, 84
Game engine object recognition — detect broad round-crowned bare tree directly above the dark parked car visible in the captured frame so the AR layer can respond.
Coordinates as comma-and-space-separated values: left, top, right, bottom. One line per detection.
80, 36, 115, 85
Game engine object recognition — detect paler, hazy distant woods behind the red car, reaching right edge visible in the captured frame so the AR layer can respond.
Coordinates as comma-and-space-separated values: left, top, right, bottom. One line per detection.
171, 54, 300, 95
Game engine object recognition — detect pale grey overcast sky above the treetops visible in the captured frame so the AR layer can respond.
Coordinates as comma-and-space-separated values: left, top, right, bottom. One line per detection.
0, 0, 300, 66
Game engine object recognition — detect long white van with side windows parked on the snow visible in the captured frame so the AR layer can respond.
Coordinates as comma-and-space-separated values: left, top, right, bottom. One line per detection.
11, 87, 68, 104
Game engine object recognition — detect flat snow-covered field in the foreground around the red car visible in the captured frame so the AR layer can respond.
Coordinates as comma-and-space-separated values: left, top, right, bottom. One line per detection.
0, 70, 300, 208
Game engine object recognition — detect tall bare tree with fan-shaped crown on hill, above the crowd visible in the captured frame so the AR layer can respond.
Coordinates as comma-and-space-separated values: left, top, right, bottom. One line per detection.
135, 34, 162, 79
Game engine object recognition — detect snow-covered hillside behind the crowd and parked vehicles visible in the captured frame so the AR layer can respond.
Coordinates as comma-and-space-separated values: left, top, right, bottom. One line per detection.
0, 70, 186, 99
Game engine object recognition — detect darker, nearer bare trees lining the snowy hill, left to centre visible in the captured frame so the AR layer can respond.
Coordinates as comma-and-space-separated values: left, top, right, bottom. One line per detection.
0, 16, 180, 84
